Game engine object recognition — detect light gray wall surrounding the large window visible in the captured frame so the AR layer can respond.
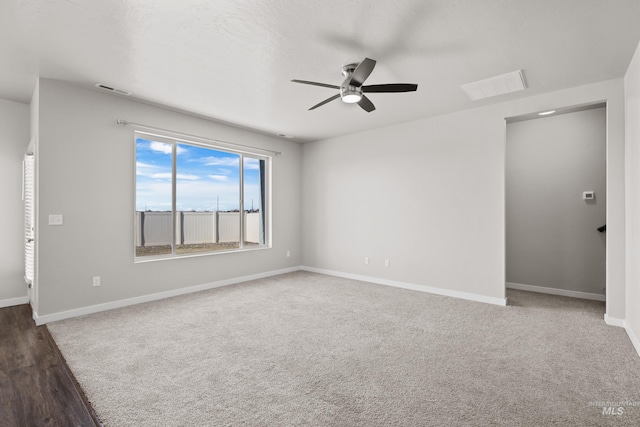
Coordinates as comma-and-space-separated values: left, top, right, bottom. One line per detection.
34, 79, 302, 318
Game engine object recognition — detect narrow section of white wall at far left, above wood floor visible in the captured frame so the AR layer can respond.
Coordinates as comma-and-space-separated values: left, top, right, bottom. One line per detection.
0, 99, 29, 307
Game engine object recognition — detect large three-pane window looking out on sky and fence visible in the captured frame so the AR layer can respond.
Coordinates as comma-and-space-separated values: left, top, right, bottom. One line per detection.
135, 132, 270, 258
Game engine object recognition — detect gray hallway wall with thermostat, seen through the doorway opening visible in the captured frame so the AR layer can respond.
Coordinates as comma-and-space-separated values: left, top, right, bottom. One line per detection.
505, 108, 606, 294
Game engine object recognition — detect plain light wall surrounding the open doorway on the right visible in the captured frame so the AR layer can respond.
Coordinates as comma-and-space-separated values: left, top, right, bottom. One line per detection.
302, 79, 625, 318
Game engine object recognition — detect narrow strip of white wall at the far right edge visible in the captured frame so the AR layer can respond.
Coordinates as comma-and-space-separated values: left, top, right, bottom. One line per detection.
624, 44, 640, 353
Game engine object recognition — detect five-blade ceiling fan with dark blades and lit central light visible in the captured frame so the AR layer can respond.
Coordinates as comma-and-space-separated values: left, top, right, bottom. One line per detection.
291, 58, 418, 113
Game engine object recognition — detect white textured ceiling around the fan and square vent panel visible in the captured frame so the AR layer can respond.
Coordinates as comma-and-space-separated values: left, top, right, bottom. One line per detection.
0, 0, 640, 142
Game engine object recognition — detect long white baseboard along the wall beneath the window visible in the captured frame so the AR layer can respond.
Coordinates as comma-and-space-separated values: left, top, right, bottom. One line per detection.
33, 267, 300, 326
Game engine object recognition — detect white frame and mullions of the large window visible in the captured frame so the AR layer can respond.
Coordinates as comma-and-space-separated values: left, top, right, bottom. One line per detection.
133, 129, 272, 263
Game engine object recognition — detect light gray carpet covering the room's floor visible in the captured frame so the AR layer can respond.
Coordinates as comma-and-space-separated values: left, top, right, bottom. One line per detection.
49, 272, 640, 426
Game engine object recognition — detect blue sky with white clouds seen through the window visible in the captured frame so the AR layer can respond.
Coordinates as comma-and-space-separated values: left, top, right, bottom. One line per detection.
136, 138, 260, 211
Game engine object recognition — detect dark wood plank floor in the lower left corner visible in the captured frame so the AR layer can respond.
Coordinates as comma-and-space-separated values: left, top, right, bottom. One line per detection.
0, 305, 101, 426
